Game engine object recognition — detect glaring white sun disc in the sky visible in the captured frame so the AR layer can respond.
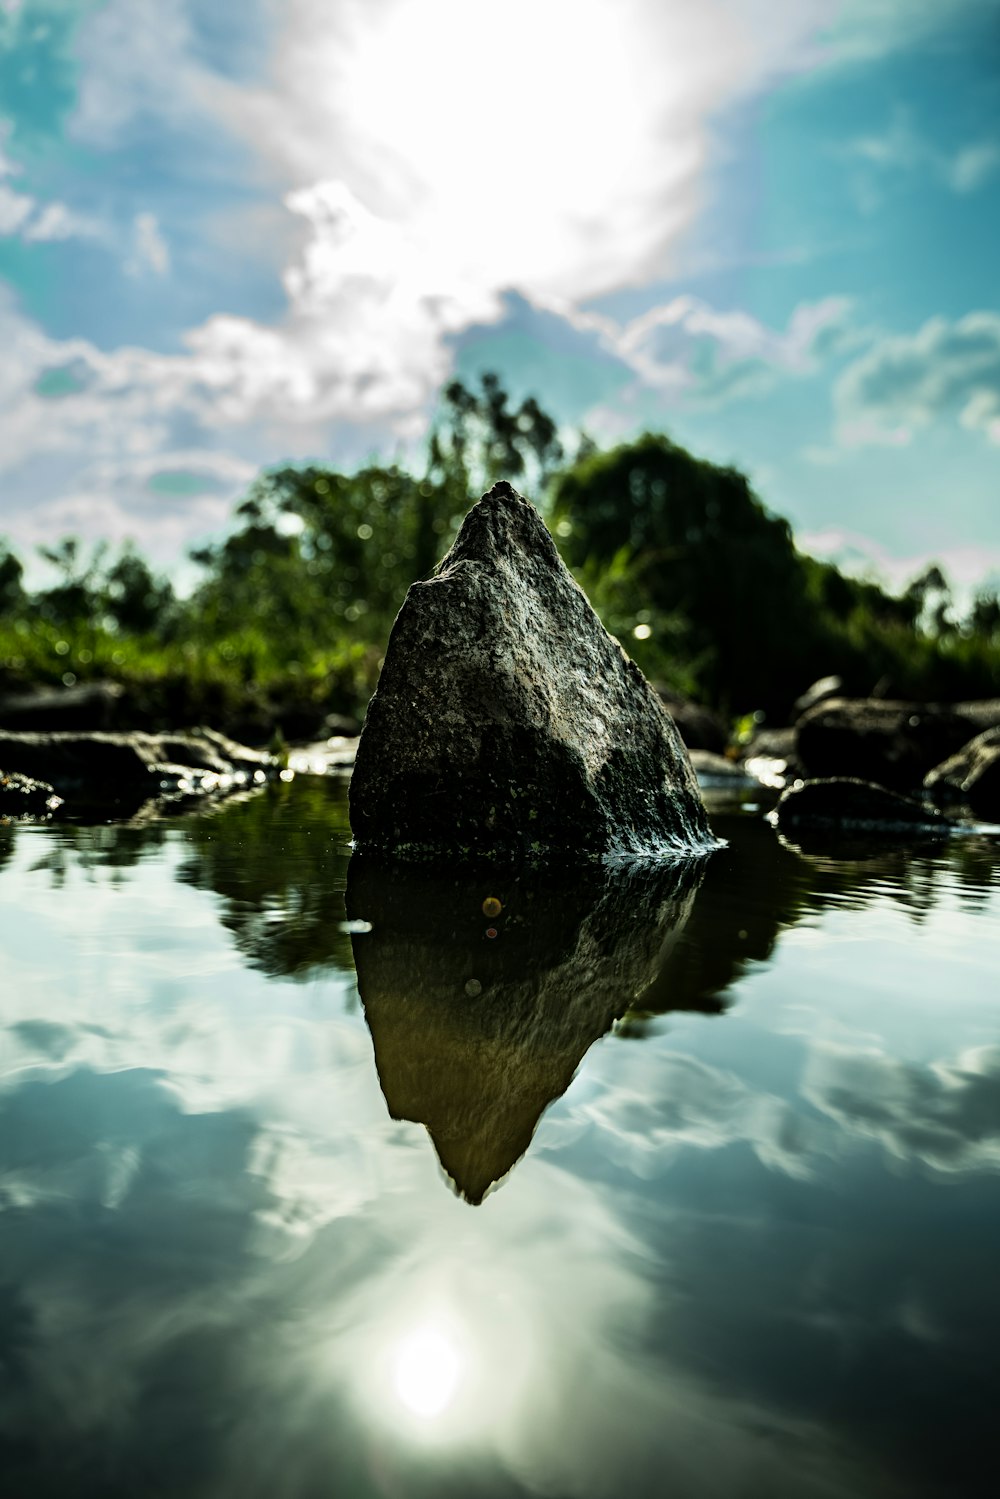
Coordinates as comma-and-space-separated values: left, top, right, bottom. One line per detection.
336, 0, 691, 295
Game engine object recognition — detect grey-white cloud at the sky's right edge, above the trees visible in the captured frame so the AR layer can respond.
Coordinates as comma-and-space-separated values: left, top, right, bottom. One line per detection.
835, 312, 1000, 445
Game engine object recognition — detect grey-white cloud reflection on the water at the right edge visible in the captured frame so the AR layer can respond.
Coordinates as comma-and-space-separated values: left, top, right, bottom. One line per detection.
804, 1046, 1000, 1172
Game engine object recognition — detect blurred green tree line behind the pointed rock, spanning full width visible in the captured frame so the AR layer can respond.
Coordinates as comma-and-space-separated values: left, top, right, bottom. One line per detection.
0, 375, 1000, 721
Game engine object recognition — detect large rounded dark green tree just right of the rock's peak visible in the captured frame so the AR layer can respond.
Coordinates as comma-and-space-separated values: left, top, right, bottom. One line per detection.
553, 433, 825, 717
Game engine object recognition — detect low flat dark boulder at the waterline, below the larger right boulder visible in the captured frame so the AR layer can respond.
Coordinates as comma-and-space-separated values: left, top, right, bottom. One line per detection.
771, 776, 955, 836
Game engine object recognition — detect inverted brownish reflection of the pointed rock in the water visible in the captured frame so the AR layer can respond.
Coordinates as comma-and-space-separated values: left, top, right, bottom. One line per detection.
346, 854, 705, 1202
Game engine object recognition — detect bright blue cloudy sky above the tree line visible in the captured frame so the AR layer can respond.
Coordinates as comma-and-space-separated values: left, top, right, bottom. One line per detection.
0, 0, 1000, 583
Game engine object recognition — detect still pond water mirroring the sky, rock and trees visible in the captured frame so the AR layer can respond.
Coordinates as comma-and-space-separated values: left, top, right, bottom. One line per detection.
0, 778, 1000, 1499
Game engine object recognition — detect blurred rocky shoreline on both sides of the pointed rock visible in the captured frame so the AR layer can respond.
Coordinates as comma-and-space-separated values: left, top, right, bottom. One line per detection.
0, 697, 1000, 839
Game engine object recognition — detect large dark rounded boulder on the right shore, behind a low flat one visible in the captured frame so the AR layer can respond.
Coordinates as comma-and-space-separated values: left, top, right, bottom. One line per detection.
796, 697, 976, 790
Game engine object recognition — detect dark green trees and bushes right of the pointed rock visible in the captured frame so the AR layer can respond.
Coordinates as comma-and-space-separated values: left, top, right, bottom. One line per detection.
552, 433, 1000, 721
